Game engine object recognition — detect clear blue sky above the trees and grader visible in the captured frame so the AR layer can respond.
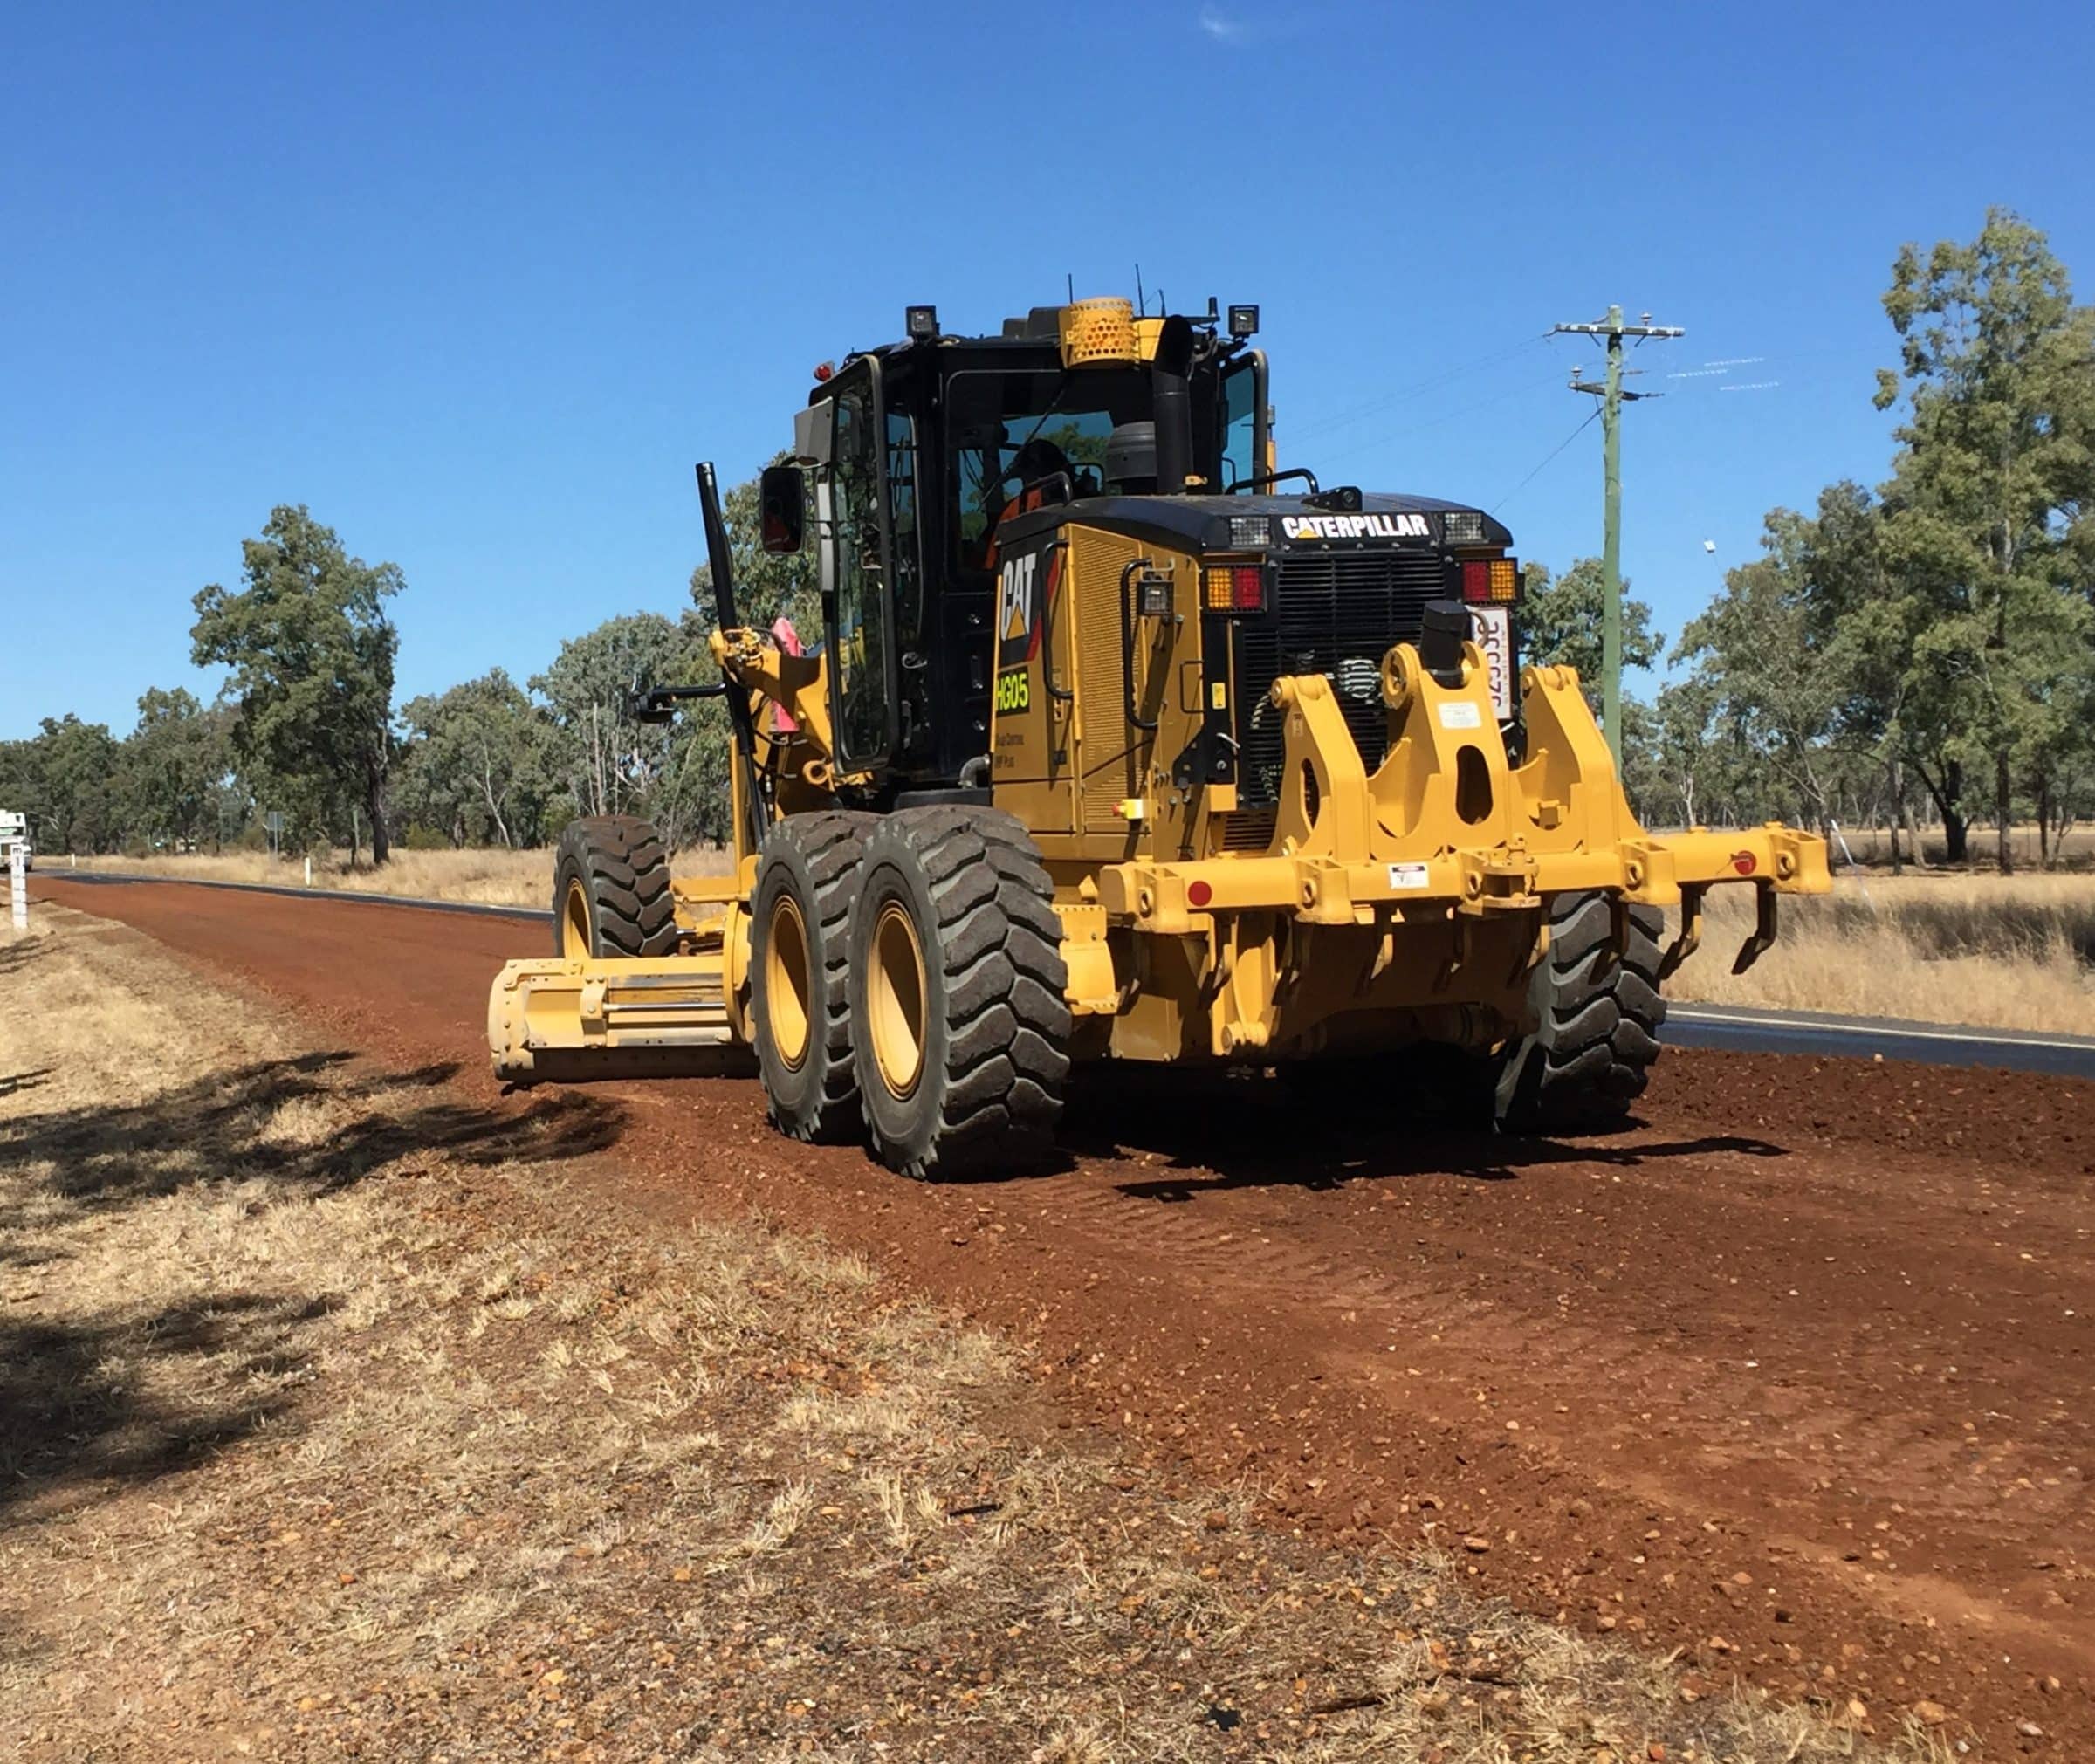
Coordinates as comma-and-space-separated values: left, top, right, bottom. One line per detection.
0, 0, 2095, 738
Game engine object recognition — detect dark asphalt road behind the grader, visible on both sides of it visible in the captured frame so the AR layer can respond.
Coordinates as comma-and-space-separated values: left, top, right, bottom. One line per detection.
44, 869, 2095, 1079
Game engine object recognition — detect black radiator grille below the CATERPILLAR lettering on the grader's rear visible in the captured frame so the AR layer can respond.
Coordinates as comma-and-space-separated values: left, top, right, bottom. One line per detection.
1236, 551, 1454, 808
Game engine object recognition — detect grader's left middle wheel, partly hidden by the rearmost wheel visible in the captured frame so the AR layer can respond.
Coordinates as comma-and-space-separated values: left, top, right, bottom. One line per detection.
750, 808, 874, 1144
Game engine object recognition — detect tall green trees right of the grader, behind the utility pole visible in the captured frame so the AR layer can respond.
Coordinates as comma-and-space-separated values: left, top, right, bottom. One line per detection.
1575, 209, 2095, 871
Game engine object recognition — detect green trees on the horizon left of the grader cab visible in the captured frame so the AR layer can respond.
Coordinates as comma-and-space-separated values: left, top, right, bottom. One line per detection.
0, 477, 819, 863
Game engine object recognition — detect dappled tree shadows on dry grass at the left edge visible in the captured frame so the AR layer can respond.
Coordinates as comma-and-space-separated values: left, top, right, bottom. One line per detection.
0, 1052, 627, 1513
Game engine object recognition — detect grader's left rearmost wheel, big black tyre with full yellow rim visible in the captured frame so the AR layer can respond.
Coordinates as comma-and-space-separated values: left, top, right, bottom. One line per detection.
850, 808, 1068, 1177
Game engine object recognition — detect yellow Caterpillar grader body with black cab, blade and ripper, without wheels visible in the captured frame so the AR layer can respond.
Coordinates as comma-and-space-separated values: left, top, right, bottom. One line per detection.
488, 299, 1831, 1110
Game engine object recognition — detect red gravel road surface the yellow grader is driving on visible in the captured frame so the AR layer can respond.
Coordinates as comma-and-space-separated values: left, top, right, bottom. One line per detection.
31, 875, 2095, 1758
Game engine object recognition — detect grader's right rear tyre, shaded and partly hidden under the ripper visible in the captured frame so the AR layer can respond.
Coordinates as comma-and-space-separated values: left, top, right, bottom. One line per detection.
1492, 895, 1666, 1134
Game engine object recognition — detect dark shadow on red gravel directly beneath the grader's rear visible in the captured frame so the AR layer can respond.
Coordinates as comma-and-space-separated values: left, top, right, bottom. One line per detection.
1062, 1051, 1787, 1203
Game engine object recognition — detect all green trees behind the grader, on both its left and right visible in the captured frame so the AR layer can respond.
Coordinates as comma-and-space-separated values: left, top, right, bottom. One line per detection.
0, 209, 2095, 869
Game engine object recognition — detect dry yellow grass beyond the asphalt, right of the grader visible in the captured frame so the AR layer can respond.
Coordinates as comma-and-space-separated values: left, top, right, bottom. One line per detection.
1667, 874, 2095, 1035
